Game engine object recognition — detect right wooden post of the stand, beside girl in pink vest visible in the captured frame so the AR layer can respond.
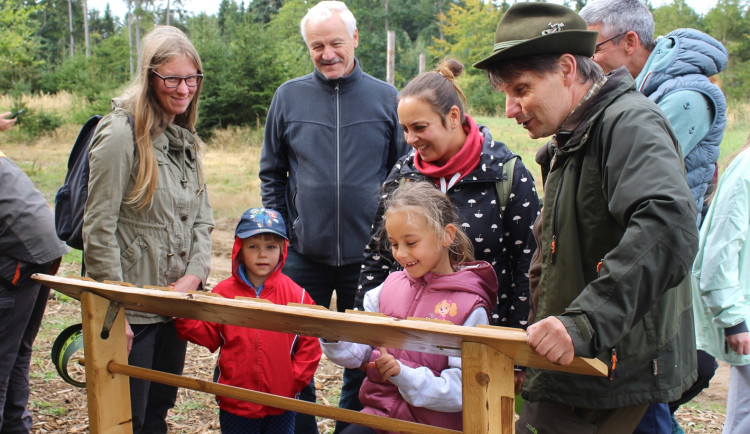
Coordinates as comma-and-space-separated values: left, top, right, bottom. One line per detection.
461, 342, 515, 434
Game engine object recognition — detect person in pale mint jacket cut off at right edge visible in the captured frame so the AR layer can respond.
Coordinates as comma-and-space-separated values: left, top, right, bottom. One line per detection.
693, 133, 750, 434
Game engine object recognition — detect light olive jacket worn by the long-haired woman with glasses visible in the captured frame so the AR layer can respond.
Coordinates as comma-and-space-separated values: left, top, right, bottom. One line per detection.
83, 108, 214, 324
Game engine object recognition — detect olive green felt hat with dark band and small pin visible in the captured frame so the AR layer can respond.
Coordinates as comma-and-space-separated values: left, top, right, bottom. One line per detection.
474, 3, 599, 69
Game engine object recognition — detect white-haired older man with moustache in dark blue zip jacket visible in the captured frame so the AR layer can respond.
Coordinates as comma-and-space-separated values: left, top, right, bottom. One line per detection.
259, 1, 407, 433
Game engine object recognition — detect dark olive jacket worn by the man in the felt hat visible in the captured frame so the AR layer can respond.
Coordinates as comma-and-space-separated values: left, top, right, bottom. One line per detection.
524, 68, 698, 409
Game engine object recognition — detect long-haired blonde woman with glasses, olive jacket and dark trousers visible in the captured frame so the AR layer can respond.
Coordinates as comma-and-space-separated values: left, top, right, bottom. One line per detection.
83, 26, 214, 433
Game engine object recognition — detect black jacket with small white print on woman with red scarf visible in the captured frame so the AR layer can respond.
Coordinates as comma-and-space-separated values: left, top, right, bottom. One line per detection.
354, 125, 539, 329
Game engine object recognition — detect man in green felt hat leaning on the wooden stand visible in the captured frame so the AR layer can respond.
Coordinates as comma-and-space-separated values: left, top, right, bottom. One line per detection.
475, 3, 698, 433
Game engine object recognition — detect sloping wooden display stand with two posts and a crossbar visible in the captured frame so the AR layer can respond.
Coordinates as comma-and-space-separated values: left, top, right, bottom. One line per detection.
34, 274, 607, 434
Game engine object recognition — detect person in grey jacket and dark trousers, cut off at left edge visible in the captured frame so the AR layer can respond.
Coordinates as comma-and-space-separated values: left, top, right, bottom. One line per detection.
0, 150, 69, 433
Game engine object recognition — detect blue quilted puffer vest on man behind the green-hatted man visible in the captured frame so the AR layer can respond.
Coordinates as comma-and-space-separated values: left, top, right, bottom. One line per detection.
636, 29, 729, 222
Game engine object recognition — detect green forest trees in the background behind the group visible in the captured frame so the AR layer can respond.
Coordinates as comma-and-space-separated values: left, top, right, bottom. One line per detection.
0, 0, 750, 137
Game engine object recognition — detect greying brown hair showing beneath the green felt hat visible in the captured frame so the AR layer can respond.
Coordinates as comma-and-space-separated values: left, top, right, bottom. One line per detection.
487, 54, 604, 89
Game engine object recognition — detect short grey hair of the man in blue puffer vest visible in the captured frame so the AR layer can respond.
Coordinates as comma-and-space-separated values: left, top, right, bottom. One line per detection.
578, 0, 656, 51
